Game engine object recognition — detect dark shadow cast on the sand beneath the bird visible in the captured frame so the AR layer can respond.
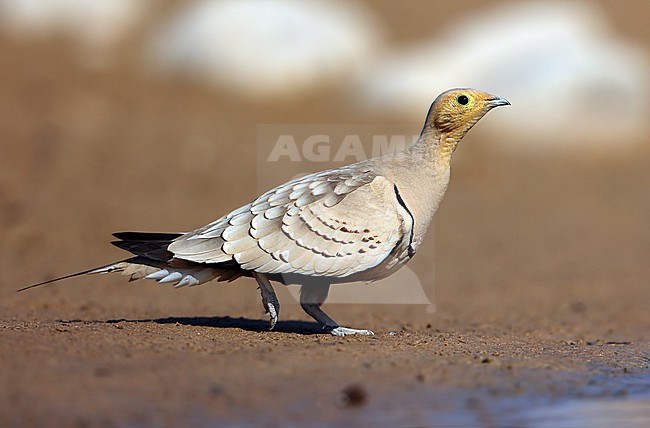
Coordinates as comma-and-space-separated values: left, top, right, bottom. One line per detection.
106, 316, 323, 335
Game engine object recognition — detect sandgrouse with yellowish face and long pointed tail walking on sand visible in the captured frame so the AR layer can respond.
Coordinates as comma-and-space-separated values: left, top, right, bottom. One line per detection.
21, 89, 510, 336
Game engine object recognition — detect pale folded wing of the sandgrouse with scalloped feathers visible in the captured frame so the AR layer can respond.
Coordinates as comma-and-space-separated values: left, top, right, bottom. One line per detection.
168, 165, 412, 278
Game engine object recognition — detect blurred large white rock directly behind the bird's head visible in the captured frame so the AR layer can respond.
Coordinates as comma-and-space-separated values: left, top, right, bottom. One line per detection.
359, 2, 650, 153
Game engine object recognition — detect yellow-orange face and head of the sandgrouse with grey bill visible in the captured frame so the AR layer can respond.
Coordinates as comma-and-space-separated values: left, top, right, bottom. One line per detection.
429, 88, 510, 138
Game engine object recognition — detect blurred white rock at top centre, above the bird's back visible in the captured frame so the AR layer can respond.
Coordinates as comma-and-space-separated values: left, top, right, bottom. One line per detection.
147, 0, 380, 98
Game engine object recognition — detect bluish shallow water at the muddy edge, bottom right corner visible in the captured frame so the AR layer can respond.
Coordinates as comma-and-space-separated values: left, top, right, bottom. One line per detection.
339, 372, 650, 428
